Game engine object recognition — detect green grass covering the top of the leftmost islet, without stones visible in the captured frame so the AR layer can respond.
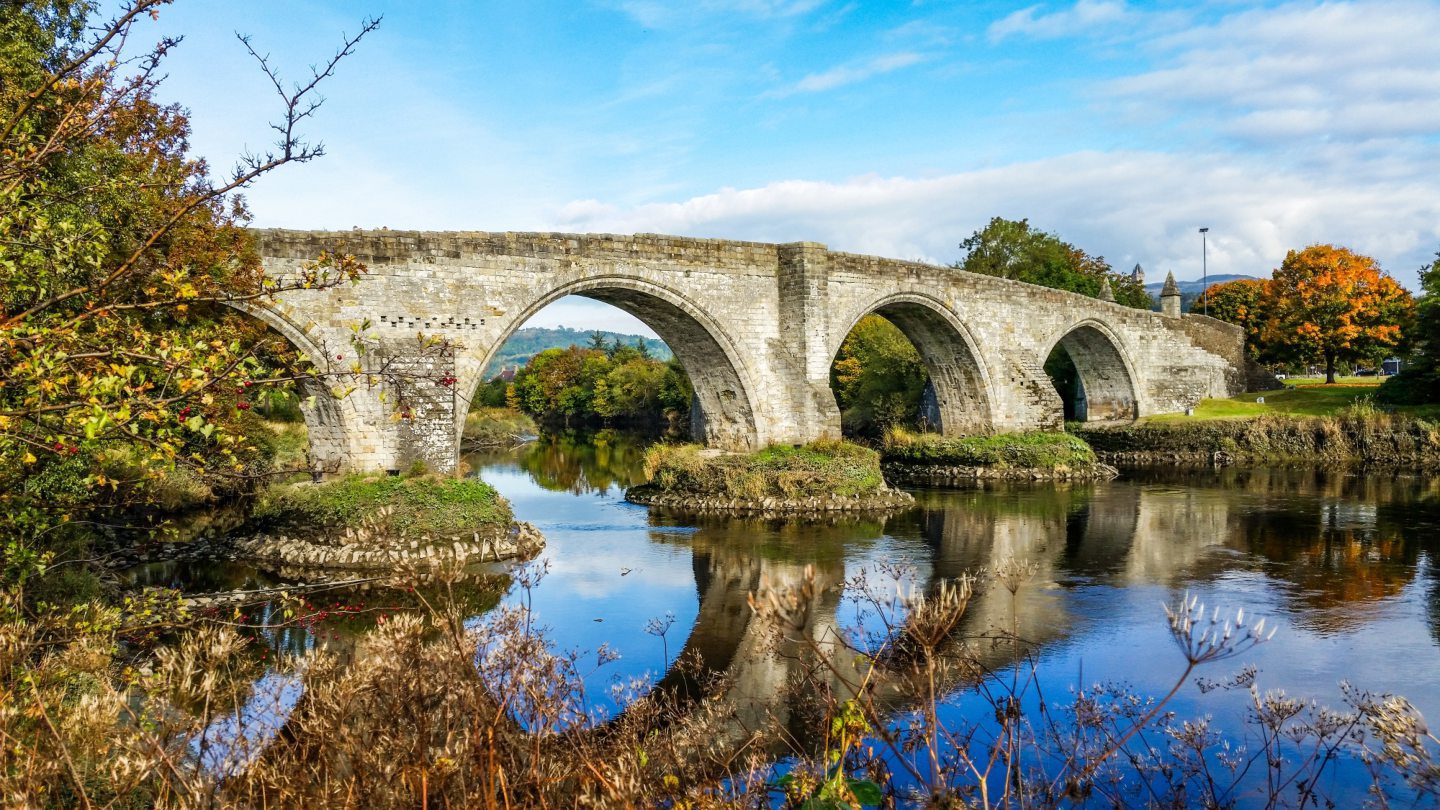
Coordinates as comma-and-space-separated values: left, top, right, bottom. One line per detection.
253, 476, 511, 539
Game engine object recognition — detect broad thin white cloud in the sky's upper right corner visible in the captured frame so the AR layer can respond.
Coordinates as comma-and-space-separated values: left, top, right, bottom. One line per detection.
1104, 1, 1440, 146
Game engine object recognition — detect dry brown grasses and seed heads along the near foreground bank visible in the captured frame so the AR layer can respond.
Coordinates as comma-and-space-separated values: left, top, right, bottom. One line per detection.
0, 561, 1440, 809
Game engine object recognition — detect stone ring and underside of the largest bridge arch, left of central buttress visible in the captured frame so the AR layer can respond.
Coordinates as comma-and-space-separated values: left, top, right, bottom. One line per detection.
469, 274, 766, 450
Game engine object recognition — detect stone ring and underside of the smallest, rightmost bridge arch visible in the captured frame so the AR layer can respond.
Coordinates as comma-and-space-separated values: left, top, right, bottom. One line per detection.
1045, 319, 1140, 422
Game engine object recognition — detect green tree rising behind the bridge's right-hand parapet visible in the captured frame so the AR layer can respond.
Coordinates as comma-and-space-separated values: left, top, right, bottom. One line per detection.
955, 216, 1153, 310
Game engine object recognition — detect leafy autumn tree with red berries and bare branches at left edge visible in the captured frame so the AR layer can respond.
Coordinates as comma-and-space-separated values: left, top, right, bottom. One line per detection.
0, 0, 377, 536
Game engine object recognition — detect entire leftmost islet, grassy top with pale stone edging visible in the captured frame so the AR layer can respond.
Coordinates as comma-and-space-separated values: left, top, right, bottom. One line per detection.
233, 476, 544, 571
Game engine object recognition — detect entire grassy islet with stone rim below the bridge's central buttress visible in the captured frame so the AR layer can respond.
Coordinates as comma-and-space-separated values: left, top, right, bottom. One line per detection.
625, 440, 914, 515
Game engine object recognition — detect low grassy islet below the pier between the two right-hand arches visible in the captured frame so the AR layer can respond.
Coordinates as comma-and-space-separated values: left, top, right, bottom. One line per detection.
881, 430, 1117, 486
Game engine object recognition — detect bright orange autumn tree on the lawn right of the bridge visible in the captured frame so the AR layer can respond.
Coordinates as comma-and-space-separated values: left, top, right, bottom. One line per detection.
1260, 245, 1416, 383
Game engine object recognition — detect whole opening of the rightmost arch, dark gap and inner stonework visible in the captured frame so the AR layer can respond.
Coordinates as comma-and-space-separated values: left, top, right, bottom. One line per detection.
1045, 323, 1140, 422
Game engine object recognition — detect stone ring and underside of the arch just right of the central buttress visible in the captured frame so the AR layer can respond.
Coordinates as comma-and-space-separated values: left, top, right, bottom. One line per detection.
829, 293, 995, 435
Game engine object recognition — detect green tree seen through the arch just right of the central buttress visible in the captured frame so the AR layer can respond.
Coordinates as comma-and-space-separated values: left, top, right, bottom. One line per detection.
829, 316, 930, 435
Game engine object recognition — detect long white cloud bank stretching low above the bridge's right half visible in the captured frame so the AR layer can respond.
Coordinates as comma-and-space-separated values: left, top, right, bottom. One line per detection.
557, 150, 1440, 287
